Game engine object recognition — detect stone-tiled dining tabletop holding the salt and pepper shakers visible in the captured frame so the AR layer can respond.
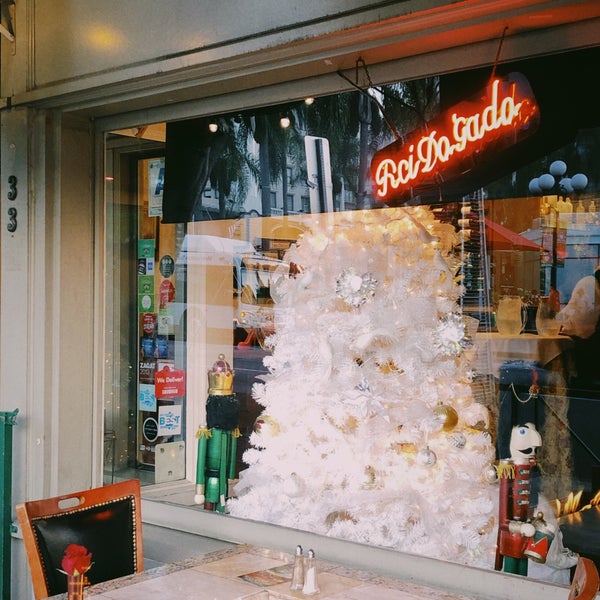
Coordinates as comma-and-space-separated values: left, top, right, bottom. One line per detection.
52, 544, 472, 600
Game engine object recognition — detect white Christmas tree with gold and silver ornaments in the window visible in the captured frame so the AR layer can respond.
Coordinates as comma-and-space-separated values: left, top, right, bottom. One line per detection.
229, 207, 497, 567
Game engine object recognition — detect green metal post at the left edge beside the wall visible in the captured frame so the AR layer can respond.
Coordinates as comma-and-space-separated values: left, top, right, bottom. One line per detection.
0, 409, 19, 600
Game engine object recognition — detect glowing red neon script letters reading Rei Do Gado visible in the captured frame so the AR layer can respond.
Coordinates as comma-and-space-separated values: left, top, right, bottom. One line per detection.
372, 79, 536, 198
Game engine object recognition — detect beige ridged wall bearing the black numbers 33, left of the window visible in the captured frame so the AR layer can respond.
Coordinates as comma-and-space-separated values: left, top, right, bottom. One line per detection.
0, 109, 94, 598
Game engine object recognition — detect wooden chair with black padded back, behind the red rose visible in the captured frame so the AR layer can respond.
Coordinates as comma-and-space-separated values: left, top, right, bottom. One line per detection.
16, 479, 144, 600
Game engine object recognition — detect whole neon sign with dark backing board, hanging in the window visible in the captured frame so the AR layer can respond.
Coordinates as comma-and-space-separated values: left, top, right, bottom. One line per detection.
371, 73, 539, 201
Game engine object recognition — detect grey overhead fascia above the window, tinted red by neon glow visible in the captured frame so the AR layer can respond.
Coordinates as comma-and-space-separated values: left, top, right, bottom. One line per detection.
0, 0, 600, 117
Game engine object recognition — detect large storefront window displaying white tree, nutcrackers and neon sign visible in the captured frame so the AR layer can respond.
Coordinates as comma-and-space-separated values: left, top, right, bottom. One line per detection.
105, 47, 600, 582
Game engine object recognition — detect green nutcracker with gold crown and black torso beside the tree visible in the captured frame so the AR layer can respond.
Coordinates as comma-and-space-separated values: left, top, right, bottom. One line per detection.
194, 354, 240, 512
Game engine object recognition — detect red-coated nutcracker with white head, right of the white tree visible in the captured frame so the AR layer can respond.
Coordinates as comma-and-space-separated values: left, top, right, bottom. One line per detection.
494, 423, 542, 575
